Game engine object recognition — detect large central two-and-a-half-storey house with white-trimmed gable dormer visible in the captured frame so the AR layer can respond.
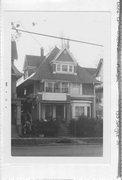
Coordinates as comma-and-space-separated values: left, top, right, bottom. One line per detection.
17, 46, 97, 126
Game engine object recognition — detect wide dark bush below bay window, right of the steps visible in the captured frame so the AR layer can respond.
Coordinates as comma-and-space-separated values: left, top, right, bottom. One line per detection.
68, 116, 103, 137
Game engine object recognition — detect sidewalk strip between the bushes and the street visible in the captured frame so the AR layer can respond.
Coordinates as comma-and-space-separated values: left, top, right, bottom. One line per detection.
11, 137, 103, 146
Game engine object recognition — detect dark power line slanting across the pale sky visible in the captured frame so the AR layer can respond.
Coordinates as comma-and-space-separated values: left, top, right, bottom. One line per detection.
12, 27, 104, 47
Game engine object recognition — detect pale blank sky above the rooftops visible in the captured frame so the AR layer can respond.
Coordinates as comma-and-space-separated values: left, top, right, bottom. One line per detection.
11, 12, 110, 72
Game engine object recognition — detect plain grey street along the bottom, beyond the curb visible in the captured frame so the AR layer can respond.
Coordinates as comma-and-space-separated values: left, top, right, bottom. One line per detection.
11, 144, 103, 157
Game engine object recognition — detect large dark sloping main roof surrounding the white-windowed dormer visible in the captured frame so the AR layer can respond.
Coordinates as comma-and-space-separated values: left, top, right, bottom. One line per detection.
18, 47, 98, 84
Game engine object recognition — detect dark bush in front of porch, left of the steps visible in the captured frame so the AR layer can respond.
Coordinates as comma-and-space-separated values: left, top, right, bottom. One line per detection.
32, 120, 59, 137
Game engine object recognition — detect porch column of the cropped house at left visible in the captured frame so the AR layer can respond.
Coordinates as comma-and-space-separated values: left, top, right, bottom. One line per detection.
16, 103, 22, 135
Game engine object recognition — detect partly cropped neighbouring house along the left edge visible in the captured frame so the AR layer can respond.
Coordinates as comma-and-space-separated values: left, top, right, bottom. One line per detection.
11, 41, 22, 136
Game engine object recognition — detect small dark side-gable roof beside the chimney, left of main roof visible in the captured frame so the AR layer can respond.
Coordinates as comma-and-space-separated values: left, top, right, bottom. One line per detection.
23, 55, 45, 70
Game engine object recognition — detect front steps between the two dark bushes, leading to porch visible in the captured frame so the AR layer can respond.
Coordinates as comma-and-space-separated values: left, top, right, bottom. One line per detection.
58, 123, 71, 137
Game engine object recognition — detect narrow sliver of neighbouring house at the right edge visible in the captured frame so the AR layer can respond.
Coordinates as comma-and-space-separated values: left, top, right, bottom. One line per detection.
95, 59, 103, 118
